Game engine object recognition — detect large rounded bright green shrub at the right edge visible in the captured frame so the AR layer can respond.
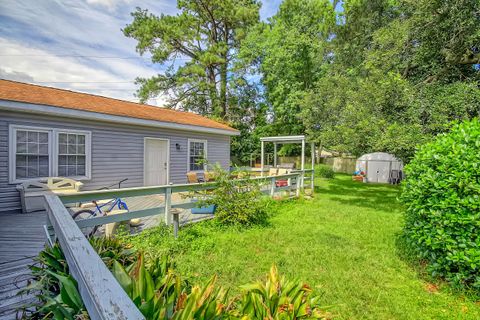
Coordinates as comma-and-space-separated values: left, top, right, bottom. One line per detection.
401, 119, 480, 290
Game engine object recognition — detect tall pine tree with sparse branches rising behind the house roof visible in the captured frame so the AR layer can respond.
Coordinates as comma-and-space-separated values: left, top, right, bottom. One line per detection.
123, 0, 260, 120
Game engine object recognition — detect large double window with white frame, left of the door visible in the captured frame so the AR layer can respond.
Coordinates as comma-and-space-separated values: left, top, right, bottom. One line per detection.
9, 126, 90, 183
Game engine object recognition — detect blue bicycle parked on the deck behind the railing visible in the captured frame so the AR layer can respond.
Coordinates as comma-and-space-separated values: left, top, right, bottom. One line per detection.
72, 178, 129, 238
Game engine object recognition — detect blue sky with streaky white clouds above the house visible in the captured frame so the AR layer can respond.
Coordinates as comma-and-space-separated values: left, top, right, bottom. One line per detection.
0, 0, 281, 106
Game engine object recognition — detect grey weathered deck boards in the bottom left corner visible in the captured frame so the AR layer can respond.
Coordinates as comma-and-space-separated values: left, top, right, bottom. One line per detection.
0, 212, 47, 319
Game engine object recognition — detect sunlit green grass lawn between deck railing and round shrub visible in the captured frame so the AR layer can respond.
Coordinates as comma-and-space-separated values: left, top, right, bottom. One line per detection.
124, 175, 480, 319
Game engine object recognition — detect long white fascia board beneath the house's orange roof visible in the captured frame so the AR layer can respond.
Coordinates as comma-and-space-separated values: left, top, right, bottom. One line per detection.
0, 99, 240, 136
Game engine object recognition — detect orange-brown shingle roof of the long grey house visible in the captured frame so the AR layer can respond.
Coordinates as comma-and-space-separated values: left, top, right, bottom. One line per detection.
0, 79, 238, 134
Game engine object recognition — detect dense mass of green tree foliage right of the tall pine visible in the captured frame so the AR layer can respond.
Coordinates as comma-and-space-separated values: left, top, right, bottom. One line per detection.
248, 0, 480, 161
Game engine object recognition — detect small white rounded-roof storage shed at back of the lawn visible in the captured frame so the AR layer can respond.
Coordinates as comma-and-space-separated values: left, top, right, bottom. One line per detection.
355, 152, 403, 183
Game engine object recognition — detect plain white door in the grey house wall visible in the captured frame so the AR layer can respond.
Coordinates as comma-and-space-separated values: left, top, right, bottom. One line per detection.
143, 138, 169, 186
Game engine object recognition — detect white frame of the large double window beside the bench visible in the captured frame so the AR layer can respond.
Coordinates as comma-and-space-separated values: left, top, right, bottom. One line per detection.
8, 124, 92, 184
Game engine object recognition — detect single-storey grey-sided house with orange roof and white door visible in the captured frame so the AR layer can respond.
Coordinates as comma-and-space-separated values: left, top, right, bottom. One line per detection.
0, 80, 239, 213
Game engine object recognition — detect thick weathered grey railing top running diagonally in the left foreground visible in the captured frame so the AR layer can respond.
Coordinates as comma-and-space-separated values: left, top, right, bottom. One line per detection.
45, 195, 145, 320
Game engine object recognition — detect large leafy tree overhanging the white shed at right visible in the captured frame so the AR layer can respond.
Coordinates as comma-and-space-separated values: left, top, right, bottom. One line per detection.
301, 0, 480, 161
